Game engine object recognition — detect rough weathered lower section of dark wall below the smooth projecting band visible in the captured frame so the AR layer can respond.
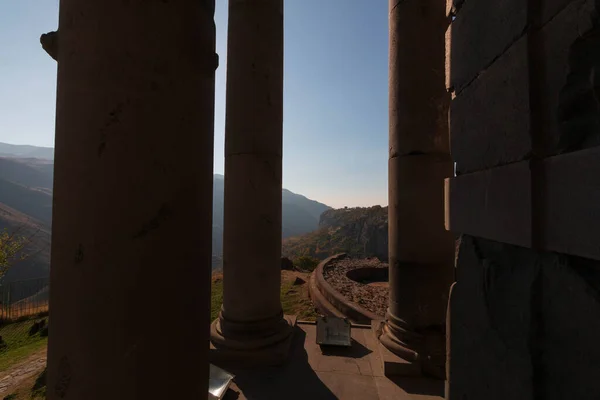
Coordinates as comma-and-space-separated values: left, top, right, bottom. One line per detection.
447, 235, 600, 400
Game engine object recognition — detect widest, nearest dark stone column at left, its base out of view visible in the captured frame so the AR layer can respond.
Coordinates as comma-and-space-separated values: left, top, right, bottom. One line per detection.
47, 0, 217, 400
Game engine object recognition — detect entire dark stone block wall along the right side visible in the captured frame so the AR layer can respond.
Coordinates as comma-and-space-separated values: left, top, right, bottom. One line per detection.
446, 0, 600, 400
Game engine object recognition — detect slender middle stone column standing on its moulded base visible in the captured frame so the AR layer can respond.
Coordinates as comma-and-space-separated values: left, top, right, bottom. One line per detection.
212, 0, 291, 363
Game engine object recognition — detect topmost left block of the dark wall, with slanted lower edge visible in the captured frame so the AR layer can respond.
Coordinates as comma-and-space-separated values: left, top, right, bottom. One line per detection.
450, 0, 527, 91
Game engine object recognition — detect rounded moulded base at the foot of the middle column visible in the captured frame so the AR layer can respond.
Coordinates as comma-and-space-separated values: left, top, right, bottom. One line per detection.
208, 315, 296, 368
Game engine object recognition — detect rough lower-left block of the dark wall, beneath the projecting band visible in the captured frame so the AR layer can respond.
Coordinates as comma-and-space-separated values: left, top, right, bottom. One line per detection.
446, 235, 539, 400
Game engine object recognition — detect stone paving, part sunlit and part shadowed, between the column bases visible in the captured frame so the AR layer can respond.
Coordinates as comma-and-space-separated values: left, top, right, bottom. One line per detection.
213, 323, 444, 400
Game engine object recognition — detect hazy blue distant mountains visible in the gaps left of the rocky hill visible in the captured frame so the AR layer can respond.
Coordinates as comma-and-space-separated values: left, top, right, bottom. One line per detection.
0, 143, 331, 281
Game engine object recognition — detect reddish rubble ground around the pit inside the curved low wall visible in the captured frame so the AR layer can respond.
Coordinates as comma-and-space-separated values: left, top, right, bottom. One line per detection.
323, 258, 389, 318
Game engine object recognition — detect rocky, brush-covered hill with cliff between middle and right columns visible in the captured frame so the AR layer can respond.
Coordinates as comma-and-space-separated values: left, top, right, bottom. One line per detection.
282, 206, 388, 261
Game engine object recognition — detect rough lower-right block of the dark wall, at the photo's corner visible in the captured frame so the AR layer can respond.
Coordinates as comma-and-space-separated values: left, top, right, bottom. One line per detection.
534, 253, 600, 400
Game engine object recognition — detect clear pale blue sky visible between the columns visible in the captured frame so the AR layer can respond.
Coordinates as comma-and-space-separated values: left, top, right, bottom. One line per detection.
0, 0, 388, 207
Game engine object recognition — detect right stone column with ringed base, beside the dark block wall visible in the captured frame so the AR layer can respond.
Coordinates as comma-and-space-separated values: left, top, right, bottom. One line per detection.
380, 0, 454, 377
